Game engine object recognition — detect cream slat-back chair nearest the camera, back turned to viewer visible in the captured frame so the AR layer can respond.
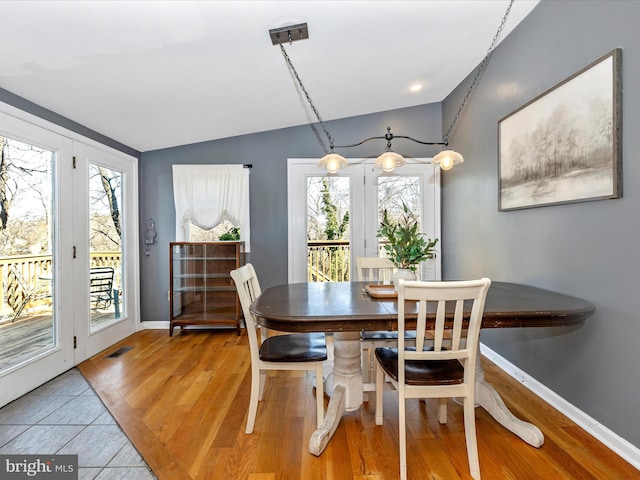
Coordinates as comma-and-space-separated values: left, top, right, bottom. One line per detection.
375, 278, 491, 480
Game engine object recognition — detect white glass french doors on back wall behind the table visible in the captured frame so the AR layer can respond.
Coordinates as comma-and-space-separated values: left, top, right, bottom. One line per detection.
287, 159, 441, 282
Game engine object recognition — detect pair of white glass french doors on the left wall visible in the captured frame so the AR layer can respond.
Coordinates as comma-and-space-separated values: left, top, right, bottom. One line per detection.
0, 104, 138, 406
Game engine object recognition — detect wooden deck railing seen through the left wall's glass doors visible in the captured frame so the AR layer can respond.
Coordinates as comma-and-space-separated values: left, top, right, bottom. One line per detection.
0, 252, 121, 315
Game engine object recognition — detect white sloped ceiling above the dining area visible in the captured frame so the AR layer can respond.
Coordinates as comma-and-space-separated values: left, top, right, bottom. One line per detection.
0, 0, 538, 151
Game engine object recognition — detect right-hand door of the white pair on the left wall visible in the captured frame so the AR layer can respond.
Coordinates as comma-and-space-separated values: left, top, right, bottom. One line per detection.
74, 142, 138, 363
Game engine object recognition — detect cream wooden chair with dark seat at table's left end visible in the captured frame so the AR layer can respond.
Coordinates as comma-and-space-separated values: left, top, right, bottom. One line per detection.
231, 263, 327, 434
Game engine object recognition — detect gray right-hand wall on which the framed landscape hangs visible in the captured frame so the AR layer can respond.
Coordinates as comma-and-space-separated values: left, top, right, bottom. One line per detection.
442, 0, 640, 447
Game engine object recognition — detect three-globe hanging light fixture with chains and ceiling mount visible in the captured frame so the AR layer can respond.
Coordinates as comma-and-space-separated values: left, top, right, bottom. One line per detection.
269, 0, 514, 174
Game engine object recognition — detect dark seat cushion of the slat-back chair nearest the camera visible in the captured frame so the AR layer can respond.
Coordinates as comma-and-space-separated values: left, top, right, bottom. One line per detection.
376, 347, 464, 385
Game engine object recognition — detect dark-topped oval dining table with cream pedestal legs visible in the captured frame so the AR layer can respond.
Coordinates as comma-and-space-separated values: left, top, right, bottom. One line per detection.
251, 281, 595, 455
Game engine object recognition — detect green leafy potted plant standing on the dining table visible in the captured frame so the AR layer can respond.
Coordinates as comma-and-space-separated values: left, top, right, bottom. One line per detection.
377, 204, 438, 272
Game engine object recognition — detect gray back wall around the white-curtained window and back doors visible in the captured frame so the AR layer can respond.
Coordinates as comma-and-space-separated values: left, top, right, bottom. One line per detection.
140, 104, 442, 321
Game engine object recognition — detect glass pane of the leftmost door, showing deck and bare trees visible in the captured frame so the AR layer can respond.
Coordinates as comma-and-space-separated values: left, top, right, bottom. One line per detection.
0, 137, 58, 372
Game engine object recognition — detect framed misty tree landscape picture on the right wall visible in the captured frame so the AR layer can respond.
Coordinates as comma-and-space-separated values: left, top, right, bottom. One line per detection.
498, 48, 622, 211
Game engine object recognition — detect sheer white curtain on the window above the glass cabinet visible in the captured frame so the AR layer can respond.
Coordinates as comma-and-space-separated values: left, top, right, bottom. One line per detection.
173, 165, 250, 251
